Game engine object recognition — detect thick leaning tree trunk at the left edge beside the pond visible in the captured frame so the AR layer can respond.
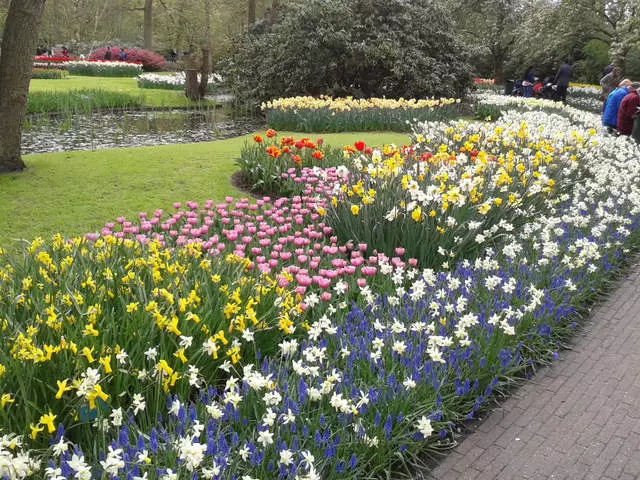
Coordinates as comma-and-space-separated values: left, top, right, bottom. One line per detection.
0, 0, 45, 172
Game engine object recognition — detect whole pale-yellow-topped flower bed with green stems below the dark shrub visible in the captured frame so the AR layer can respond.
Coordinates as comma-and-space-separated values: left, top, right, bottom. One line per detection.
262, 97, 460, 132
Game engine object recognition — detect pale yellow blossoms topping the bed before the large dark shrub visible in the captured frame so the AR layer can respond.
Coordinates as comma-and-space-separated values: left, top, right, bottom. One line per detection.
262, 96, 460, 112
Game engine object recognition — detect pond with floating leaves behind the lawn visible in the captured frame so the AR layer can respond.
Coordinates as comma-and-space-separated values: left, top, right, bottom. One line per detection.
22, 108, 264, 154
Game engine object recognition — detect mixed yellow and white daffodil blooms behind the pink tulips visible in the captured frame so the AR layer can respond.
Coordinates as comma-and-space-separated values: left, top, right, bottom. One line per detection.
338, 122, 590, 233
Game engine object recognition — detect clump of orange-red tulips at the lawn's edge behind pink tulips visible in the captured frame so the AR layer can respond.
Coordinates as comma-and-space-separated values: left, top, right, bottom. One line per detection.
236, 129, 343, 195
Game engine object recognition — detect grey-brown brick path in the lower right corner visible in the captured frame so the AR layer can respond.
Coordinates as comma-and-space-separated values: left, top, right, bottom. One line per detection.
426, 265, 640, 480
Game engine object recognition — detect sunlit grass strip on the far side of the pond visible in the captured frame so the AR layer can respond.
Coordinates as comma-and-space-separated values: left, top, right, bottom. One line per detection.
29, 75, 197, 107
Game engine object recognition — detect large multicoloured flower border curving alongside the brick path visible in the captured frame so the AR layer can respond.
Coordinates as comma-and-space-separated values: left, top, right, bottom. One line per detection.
0, 93, 640, 480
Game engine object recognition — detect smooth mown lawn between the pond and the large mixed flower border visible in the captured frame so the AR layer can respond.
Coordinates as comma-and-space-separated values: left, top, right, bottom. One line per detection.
0, 131, 409, 251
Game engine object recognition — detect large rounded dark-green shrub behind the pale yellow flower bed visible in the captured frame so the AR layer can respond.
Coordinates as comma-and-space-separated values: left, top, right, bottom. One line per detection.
222, 0, 470, 100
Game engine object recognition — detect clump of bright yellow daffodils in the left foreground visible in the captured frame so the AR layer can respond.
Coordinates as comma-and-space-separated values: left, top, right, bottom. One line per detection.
0, 235, 302, 439
